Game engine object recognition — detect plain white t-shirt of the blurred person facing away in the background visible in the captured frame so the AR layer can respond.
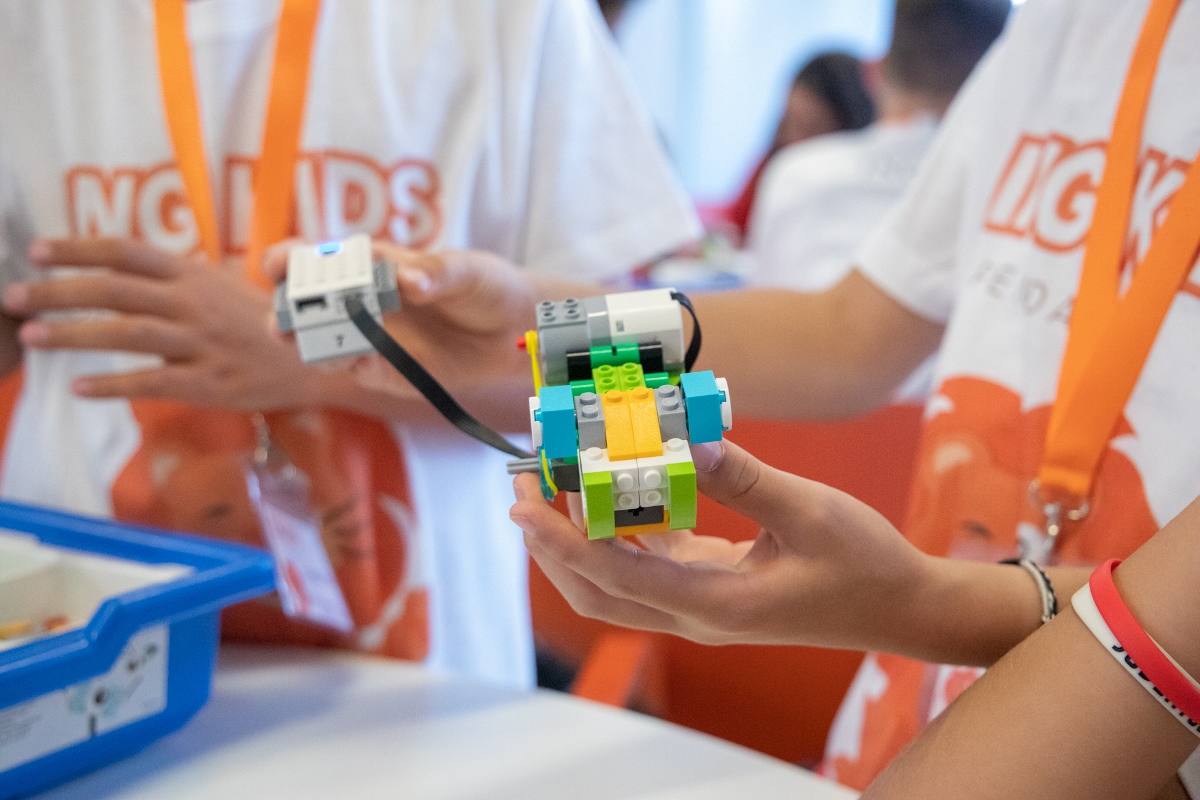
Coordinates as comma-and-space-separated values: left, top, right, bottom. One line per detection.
748, 115, 937, 291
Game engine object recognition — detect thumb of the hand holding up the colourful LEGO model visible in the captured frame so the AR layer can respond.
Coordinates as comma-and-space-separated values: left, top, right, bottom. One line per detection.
691, 439, 823, 529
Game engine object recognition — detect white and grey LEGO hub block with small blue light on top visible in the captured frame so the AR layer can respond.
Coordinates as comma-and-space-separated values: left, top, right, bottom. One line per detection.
275, 234, 400, 362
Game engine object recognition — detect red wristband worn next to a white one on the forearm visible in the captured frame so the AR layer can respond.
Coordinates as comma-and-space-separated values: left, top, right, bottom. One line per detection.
1088, 559, 1200, 721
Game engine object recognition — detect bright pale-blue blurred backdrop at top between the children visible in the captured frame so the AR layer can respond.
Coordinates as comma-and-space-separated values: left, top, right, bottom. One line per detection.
601, 0, 893, 207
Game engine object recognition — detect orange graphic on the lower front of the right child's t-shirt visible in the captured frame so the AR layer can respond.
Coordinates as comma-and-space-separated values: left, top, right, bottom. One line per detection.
824, 377, 1158, 789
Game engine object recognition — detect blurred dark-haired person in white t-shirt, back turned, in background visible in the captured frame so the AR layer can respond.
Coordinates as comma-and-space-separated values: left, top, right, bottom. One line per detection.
746, 0, 1012, 291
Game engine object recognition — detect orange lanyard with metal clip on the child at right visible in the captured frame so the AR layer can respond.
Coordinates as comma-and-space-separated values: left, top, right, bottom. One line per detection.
1033, 0, 1200, 536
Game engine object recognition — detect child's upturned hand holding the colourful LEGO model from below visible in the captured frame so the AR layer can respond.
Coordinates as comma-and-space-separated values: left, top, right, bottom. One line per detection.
511, 441, 936, 650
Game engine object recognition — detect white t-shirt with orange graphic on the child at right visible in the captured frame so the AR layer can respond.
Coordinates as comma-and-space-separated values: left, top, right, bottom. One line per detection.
826, 0, 1200, 786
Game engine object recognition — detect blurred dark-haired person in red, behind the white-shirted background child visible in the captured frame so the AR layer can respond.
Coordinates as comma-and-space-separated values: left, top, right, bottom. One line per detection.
721, 52, 875, 242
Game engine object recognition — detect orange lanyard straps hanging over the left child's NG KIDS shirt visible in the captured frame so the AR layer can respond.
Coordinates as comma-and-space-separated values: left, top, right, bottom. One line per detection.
155, 0, 320, 289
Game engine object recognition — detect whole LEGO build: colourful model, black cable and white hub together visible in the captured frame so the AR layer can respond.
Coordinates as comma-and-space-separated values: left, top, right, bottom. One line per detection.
275, 235, 733, 539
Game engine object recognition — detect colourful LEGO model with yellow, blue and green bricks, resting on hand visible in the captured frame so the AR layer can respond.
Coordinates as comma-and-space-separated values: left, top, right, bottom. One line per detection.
510, 289, 733, 539
